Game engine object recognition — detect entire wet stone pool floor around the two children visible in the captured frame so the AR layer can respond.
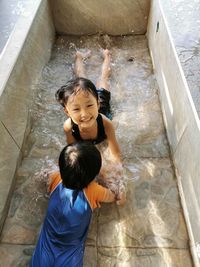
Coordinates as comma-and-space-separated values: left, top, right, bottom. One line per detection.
0, 36, 193, 267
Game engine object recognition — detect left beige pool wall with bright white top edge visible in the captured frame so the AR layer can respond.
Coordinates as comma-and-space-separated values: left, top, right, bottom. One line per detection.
0, 1, 55, 230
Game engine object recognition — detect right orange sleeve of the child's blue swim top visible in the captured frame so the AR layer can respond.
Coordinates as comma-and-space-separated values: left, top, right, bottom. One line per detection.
84, 181, 108, 209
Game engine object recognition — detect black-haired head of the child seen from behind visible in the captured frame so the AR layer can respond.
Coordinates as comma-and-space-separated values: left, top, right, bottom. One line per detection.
59, 142, 101, 190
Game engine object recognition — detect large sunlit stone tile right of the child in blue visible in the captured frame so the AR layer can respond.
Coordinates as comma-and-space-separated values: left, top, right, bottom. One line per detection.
98, 159, 188, 248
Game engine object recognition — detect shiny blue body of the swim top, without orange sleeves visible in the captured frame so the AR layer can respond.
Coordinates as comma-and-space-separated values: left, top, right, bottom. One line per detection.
29, 182, 92, 267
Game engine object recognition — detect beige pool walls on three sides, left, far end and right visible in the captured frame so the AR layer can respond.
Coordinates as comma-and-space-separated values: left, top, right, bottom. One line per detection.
0, 0, 200, 266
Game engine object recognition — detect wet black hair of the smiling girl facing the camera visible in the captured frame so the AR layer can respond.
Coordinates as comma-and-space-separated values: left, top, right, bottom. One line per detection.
55, 77, 98, 107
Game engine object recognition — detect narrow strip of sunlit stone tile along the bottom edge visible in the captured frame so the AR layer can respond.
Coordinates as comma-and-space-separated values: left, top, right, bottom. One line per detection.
97, 248, 193, 267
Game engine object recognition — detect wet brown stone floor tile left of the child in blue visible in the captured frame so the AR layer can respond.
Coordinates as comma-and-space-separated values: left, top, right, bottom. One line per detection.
1, 174, 48, 244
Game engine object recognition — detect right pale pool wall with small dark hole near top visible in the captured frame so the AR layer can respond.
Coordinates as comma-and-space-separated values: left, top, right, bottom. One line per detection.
147, 0, 200, 266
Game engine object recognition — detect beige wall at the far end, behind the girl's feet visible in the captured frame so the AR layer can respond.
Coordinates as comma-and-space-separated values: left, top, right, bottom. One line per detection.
51, 0, 150, 35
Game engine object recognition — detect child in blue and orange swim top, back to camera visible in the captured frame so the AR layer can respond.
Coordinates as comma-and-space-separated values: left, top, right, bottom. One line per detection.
29, 142, 115, 267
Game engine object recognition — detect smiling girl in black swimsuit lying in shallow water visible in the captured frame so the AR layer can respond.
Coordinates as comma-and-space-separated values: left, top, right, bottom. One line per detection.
56, 49, 125, 204
